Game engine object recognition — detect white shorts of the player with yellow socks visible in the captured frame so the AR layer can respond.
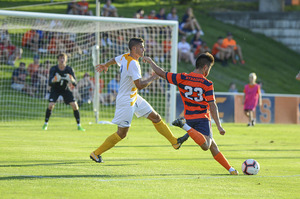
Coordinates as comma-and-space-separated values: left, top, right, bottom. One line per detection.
112, 95, 153, 127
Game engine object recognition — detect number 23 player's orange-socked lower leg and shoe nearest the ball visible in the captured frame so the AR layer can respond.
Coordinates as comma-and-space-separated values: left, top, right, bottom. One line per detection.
210, 139, 239, 175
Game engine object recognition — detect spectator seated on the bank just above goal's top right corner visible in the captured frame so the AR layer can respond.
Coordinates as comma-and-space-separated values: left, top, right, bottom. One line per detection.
180, 8, 204, 35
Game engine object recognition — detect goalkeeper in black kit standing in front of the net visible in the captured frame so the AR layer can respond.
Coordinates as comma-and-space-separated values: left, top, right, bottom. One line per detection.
43, 53, 85, 131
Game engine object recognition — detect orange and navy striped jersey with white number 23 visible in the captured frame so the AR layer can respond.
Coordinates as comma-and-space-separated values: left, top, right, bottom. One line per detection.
166, 72, 215, 120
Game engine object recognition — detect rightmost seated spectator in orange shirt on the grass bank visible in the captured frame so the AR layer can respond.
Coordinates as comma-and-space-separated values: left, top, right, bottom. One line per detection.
222, 32, 245, 64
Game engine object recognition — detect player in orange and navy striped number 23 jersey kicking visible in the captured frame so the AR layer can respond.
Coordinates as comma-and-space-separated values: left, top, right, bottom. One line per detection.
143, 53, 238, 175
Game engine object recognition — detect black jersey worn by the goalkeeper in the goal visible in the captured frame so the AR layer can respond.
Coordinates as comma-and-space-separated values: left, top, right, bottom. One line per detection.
49, 65, 76, 91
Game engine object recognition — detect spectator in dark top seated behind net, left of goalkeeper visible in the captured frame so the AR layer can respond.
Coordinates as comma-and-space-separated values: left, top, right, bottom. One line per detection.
11, 62, 34, 96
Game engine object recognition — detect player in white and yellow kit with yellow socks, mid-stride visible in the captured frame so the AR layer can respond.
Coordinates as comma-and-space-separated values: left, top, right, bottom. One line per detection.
90, 38, 187, 163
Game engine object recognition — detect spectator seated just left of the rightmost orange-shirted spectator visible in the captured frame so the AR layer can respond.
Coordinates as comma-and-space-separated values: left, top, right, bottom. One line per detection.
211, 37, 233, 66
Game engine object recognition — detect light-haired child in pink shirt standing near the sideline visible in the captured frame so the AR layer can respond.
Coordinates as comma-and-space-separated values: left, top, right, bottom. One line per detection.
243, 73, 262, 126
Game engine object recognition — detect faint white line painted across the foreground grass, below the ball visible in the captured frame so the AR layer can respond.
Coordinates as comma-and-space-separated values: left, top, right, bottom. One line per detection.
0, 174, 300, 182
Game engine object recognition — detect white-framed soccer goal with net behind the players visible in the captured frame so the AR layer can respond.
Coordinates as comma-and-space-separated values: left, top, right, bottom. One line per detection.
0, 10, 178, 123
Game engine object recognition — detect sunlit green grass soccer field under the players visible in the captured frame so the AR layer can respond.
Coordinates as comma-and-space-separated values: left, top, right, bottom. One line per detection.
0, 118, 300, 198
